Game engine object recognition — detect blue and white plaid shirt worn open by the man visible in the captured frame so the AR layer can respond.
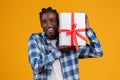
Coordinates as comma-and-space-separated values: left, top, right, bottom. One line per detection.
29, 29, 103, 80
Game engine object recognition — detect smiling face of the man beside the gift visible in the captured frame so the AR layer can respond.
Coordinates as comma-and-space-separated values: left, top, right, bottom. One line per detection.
40, 12, 59, 39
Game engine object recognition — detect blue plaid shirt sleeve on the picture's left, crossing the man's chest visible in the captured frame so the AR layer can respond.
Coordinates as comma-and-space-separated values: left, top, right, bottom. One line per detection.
28, 35, 61, 74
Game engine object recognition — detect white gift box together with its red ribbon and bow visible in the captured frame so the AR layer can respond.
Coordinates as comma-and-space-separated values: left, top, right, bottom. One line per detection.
59, 12, 87, 50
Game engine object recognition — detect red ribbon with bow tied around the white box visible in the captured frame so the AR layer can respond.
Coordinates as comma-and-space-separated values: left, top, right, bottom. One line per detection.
59, 13, 87, 51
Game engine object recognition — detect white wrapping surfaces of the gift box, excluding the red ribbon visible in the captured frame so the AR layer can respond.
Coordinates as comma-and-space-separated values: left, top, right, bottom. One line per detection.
59, 12, 86, 46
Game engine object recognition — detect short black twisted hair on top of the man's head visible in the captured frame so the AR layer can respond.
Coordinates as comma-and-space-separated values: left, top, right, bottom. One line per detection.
39, 7, 59, 20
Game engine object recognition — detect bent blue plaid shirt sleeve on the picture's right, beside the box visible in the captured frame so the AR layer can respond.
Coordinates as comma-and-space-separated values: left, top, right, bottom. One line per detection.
79, 29, 103, 58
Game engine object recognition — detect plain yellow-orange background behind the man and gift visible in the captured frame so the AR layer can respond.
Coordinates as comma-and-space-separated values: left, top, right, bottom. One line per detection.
0, 0, 120, 80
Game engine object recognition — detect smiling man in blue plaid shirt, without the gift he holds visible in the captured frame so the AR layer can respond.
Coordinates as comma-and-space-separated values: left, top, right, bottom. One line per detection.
29, 7, 103, 80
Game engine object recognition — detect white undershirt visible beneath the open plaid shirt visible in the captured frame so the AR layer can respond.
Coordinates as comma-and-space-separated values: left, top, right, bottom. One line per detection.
48, 40, 63, 80
